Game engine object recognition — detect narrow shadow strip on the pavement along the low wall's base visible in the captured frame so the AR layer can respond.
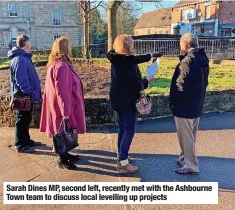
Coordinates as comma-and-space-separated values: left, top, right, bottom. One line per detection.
88, 112, 235, 133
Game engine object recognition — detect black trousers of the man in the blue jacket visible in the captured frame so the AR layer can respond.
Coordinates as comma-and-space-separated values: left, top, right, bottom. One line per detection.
15, 109, 32, 148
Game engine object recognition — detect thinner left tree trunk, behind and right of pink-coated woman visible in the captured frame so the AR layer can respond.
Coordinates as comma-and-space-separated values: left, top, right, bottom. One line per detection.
83, 1, 91, 59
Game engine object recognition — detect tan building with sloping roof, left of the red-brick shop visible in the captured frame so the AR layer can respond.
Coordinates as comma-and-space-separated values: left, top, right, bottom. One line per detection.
134, 8, 171, 36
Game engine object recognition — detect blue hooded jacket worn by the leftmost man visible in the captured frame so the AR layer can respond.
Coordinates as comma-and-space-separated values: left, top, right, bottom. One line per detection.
8, 47, 41, 103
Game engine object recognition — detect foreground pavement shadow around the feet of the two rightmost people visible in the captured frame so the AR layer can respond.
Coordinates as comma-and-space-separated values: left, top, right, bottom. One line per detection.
78, 150, 235, 190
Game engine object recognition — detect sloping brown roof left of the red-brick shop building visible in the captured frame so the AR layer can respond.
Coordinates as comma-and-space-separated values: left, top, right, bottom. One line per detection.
135, 8, 172, 29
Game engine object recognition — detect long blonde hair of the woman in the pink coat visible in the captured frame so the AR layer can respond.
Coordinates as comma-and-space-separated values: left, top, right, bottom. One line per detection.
47, 36, 72, 67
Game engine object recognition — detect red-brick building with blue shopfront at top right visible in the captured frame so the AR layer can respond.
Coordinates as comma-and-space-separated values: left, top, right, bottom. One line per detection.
171, 0, 235, 37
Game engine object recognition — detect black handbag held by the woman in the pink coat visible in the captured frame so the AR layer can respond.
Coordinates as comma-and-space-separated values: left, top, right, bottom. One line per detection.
53, 118, 79, 155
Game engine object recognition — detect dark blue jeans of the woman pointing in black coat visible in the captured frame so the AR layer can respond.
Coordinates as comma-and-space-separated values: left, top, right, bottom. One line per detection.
117, 112, 137, 161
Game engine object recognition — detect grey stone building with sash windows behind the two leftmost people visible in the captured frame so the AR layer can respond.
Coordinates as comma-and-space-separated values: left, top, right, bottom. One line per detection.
0, 0, 82, 49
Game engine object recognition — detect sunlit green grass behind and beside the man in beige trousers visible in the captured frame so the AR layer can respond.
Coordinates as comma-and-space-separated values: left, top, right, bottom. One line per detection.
139, 58, 235, 95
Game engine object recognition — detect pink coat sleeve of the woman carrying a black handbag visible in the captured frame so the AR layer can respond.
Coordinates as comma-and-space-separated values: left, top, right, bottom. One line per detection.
55, 65, 72, 116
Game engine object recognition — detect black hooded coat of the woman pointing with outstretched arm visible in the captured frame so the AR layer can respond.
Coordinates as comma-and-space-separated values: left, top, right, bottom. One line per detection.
107, 51, 151, 113
